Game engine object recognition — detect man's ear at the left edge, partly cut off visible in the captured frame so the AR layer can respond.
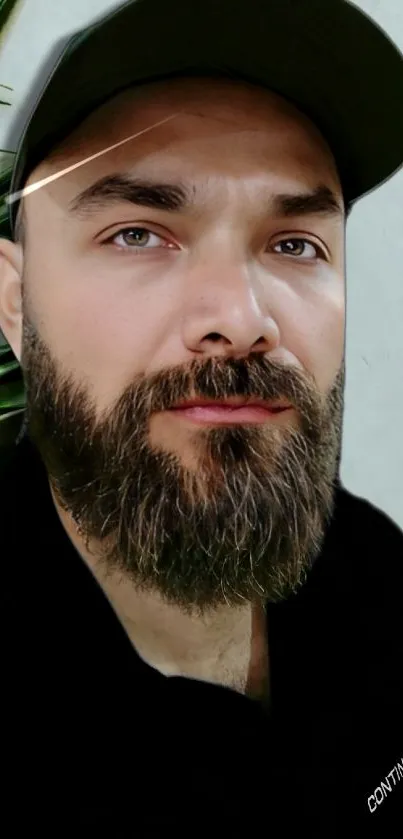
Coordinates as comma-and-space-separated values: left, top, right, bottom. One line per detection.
0, 238, 24, 361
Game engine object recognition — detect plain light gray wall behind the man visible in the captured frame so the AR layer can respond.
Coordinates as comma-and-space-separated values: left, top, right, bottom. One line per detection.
0, 0, 403, 527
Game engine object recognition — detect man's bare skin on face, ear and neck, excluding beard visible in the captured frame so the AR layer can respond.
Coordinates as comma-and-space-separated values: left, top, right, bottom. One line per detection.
0, 79, 345, 695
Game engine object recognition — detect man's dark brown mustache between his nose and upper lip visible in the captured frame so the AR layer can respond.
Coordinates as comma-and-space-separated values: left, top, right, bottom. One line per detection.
115, 354, 323, 430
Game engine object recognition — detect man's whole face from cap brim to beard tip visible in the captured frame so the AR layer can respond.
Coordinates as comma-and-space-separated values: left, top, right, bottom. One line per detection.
0, 80, 344, 609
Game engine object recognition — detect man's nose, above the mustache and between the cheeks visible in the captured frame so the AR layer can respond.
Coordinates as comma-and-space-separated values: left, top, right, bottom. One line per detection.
183, 261, 280, 358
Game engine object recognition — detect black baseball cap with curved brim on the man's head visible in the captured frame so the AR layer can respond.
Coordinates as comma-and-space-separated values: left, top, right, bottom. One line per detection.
9, 0, 403, 232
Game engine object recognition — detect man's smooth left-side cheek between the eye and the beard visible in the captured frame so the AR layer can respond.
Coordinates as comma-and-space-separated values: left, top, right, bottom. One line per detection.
25, 253, 172, 406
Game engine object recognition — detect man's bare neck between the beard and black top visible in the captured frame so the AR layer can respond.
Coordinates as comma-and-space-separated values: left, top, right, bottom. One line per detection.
52, 491, 268, 699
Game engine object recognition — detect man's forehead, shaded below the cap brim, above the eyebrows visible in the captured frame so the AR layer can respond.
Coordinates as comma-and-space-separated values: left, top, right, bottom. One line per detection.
27, 78, 339, 212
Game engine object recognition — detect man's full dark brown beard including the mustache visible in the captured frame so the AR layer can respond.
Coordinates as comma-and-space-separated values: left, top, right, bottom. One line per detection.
21, 317, 344, 615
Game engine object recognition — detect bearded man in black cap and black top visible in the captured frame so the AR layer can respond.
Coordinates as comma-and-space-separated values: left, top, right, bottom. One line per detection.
0, 0, 403, 836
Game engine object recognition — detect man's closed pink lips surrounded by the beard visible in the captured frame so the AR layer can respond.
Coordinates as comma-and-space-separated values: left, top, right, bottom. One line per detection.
170, 396, 292, 425
